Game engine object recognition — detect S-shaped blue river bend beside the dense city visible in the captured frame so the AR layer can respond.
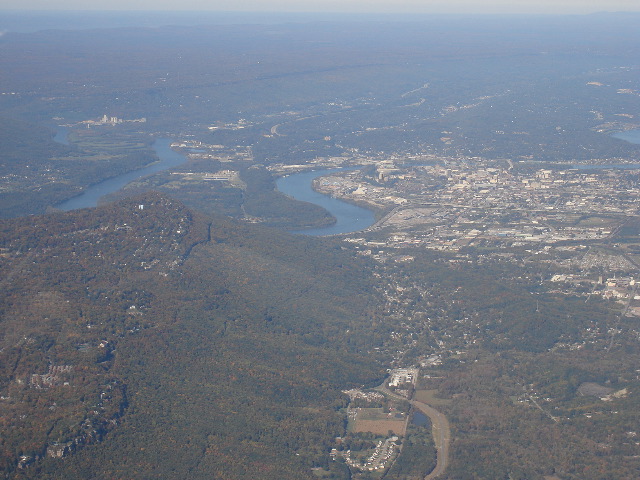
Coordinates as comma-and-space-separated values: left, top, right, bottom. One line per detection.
276, 169, 375, 236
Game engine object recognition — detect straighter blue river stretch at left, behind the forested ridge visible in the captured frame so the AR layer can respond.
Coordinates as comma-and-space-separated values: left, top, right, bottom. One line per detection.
56, 138, 186, 211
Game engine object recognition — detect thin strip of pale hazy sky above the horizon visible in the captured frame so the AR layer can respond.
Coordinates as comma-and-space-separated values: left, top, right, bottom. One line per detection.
0, 0, 640, 14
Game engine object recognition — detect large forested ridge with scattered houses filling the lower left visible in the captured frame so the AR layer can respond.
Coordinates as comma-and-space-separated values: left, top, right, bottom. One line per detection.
0, 194, 383, 479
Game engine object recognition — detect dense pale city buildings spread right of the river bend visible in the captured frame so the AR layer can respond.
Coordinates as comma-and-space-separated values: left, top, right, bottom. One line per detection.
315, 158, 640, 255
